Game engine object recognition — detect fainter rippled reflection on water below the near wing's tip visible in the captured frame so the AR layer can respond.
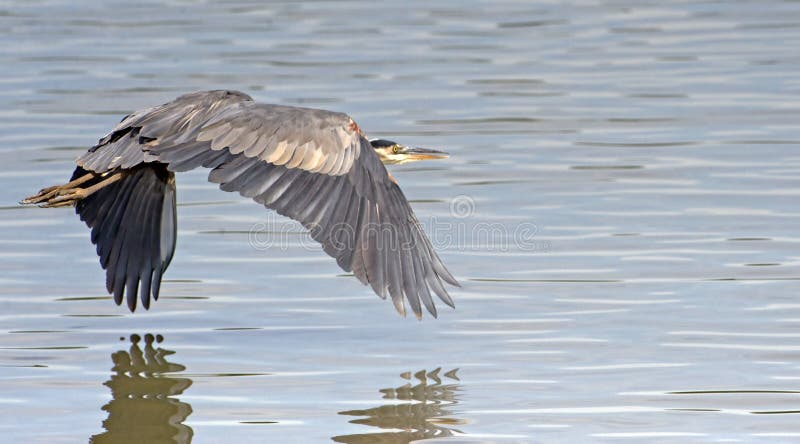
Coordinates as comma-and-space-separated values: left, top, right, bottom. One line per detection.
332, 368, 465, 444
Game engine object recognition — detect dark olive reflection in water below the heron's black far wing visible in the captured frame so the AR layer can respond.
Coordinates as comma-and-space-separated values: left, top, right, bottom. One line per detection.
90, 334, 193, 444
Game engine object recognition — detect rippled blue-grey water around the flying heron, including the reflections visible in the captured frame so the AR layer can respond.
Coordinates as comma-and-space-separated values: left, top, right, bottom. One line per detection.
0, 1, 800, 443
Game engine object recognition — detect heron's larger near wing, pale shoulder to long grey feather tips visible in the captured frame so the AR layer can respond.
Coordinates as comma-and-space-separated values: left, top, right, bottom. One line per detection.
78, 91, 458, 317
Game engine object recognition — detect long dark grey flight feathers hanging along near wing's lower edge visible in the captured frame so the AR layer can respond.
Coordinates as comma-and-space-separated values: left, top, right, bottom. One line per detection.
200, 141, 458, 316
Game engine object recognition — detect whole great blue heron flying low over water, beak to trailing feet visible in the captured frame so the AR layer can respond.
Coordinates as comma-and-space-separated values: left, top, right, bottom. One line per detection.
22, 90, 459, 317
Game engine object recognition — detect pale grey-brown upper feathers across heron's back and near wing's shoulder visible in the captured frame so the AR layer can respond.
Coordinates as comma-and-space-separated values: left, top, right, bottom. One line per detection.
78, 91, 361, 175
